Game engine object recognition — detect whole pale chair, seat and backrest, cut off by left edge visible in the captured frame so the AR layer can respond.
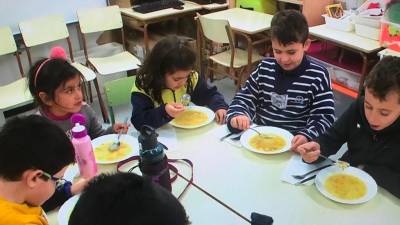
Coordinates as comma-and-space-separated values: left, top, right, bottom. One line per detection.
0, 27, 33, 127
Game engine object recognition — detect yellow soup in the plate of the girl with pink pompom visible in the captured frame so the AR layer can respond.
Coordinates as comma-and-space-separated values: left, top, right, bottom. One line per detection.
94, 141, 132, 161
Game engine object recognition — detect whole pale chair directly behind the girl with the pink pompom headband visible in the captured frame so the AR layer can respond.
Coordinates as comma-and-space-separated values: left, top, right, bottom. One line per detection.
19, 15, 108, 122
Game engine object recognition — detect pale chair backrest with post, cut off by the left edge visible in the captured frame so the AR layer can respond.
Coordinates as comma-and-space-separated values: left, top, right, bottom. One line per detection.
0, 27, 24, 77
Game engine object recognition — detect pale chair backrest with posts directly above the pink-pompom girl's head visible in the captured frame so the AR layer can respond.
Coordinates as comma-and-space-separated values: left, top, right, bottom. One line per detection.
19, 14, 74, 66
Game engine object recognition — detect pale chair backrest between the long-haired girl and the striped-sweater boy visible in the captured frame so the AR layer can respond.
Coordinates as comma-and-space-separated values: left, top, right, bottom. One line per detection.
198, 16, 232, 43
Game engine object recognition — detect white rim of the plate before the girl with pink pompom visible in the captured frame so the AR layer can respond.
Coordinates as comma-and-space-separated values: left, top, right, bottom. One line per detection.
92, 134, 139, 164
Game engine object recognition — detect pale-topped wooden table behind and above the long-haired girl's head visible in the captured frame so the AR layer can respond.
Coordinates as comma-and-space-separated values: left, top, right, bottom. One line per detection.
120, 1, 203, 53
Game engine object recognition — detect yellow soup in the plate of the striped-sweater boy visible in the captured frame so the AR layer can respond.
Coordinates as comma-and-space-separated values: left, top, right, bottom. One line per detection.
249, 134, 286, 152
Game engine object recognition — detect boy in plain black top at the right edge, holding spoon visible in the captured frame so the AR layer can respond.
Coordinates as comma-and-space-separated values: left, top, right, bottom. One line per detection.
298, 56, 400, 198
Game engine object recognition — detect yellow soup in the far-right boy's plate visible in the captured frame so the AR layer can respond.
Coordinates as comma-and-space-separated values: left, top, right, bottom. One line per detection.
324, 174, 367, 200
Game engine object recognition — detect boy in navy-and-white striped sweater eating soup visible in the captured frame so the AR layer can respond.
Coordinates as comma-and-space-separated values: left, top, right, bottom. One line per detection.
227, 10, 335, 150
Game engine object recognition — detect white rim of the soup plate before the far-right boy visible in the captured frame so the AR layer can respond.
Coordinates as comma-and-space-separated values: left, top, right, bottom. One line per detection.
315, 166, 378, 204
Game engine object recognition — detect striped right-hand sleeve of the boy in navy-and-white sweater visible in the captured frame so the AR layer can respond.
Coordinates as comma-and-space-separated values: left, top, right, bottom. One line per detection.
298, 70, 335, 140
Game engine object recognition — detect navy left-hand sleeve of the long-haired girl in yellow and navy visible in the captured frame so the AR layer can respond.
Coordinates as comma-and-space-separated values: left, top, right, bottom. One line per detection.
131, 92, 173, 130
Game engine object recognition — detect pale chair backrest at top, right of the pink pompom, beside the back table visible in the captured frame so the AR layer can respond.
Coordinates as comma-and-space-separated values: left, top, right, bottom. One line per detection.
77, 5, 123, 34
